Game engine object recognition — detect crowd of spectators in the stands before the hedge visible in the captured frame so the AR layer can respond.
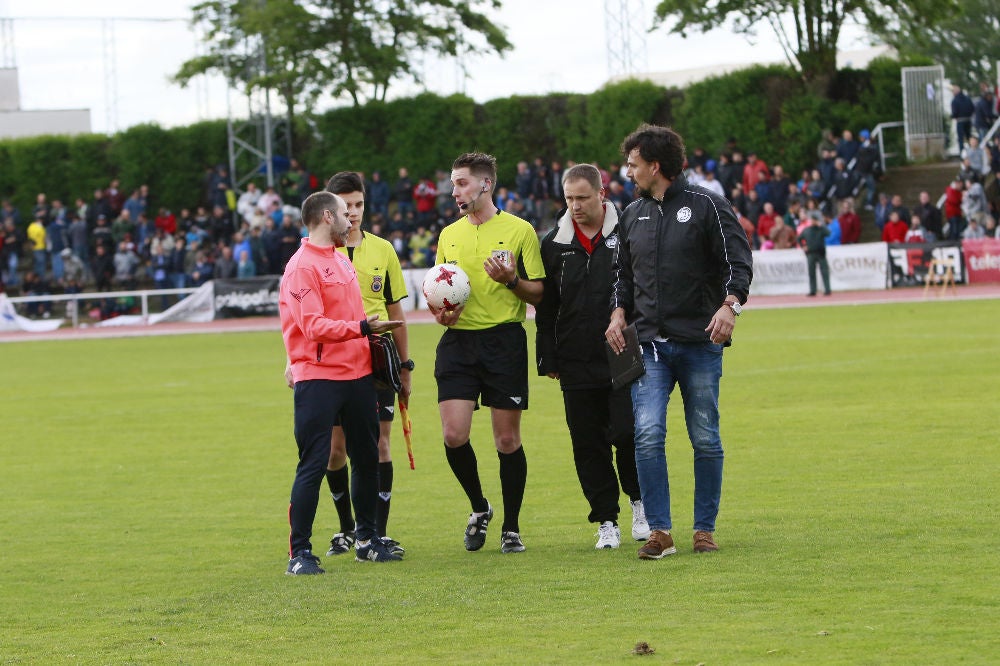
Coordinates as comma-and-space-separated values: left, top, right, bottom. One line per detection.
7, 104, 1000, 316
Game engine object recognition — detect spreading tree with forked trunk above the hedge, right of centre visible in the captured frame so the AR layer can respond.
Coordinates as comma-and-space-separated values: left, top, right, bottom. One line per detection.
653, 0, 958, 93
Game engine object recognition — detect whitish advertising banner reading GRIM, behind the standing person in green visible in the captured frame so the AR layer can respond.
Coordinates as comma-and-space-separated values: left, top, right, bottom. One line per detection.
750, 243, 889, 296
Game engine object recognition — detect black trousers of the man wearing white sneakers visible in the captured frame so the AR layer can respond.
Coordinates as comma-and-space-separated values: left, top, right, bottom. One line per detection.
563, 387, 642, 523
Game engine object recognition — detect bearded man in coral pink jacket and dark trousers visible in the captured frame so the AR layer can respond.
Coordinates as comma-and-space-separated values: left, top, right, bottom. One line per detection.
278, 192, 403, 575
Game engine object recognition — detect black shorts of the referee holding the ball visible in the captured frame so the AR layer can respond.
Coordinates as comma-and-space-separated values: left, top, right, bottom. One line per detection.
434, 322, 528, 409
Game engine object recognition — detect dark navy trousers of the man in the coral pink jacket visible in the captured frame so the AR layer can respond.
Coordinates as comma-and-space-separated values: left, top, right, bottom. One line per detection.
288, 375, 378, 557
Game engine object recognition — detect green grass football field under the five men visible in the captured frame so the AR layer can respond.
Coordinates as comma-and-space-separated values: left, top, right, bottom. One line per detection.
0, 301, 1000, 666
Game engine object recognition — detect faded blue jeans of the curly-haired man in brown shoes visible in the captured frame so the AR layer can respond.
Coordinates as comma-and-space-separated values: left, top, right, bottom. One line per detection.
632, 341, 723, 532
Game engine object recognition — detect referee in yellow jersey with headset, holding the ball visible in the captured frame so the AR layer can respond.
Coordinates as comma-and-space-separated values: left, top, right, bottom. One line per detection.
431, 153, 545, 553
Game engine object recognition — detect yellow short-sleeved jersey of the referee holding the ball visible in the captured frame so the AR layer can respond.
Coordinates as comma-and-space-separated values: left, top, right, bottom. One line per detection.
435, 211, 545, 331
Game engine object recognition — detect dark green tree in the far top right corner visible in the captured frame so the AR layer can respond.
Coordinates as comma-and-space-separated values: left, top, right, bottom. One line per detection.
879, 0, 1000, 91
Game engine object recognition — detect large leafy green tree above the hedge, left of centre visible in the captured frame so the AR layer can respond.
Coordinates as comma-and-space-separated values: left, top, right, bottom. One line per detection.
174, 0, 513, 111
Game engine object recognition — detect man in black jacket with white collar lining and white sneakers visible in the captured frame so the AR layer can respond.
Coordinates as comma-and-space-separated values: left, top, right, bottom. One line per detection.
535, 164, 649, 549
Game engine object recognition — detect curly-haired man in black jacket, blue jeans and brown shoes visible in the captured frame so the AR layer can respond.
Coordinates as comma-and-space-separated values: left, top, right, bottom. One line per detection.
605, 124, 753, 560
